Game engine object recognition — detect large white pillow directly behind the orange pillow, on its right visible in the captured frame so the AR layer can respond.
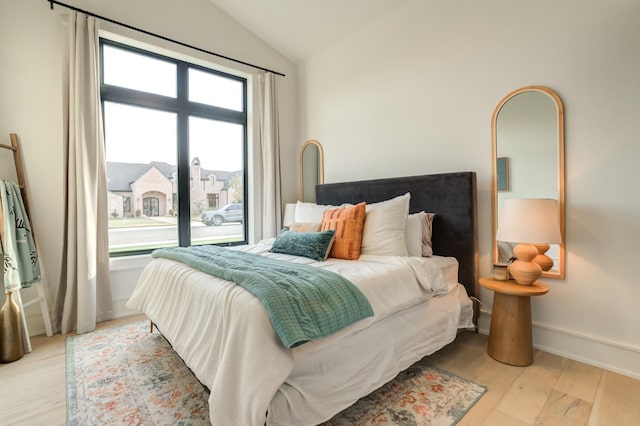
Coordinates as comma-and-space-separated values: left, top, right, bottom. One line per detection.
360, 192, 411, 256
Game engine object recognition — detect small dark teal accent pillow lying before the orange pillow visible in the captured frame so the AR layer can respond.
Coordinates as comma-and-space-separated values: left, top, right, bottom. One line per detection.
269, 230, 335, 262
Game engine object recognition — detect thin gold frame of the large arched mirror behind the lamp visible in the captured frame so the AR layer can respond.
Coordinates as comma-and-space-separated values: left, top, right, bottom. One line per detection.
491, 86, 566, 279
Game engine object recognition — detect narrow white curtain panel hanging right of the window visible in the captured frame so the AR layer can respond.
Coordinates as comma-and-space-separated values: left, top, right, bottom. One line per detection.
255, 72, 282, 239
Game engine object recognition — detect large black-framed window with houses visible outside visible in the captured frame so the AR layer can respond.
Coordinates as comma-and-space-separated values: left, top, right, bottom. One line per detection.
100, 39, 247, 255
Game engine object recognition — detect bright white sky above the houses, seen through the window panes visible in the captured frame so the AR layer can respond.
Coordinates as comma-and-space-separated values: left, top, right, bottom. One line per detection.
104, 46, 243, 171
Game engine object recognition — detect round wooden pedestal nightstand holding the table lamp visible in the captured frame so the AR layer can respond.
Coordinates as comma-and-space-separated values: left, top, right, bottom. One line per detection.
480, 278, 549, 366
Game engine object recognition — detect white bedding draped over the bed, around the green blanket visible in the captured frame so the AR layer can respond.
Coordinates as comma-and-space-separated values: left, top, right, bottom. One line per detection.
127, 241, 472, 425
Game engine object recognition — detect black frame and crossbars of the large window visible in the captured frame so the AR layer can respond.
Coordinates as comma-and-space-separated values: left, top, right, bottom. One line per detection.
99, 37, 249, 257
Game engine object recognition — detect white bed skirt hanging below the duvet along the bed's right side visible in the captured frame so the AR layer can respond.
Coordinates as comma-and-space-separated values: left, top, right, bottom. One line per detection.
267, 284, 473, 426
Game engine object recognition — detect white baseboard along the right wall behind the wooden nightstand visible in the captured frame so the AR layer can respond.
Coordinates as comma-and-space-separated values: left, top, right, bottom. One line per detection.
478, 309, 640, 379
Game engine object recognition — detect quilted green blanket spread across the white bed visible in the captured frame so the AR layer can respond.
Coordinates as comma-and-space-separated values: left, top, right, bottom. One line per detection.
152, 246, 373, 348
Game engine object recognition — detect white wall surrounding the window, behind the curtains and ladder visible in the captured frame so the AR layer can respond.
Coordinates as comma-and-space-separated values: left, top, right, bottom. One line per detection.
0, 0, 301, 334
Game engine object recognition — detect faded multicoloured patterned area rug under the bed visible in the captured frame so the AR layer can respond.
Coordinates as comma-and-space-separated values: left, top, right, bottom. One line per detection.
66, 321, 486, 426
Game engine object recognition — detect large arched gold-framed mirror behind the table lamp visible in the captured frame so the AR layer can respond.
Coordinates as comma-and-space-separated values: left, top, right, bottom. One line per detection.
491, 86, 565, 279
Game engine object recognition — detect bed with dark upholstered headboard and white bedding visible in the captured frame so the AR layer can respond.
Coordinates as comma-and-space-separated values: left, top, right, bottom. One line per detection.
127, 172, 478, 425
